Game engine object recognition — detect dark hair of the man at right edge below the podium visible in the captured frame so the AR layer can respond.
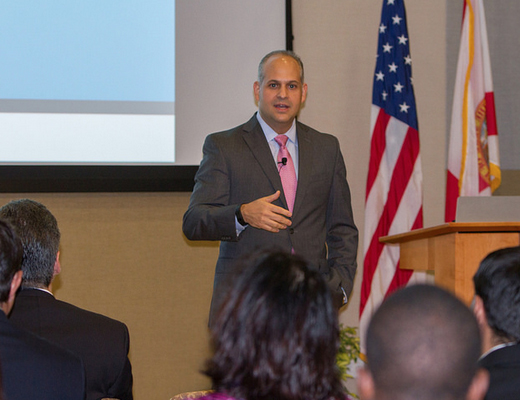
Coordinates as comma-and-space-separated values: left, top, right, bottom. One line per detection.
473, 246, 520, 342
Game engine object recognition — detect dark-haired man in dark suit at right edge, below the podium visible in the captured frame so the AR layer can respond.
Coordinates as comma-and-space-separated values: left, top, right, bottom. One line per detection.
473, 246, 520, 400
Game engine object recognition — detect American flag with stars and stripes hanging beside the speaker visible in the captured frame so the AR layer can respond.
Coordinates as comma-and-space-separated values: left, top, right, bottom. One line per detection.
360, 0, 423, 351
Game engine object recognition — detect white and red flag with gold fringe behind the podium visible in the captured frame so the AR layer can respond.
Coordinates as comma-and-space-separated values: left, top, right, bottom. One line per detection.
445, 0, 501, 222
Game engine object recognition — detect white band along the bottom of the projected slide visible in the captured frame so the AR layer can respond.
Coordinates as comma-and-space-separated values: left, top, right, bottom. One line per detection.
0, 113, 175, 164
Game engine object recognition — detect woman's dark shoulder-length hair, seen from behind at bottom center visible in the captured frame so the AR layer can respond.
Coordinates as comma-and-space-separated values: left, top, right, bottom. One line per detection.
205, 252, 344, 400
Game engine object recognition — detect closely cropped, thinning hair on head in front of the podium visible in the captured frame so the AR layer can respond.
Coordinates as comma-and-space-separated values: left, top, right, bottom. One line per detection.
366, 284, 481, 400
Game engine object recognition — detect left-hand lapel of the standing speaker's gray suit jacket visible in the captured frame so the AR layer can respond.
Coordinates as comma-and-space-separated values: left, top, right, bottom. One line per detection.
243, 114, 287, 208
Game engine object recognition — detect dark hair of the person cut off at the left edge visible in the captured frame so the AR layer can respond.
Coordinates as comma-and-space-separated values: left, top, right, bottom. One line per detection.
0, 219, 23, 303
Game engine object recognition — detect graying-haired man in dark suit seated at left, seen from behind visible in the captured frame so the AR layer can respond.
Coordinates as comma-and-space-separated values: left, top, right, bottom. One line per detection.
0, 199, 133, 400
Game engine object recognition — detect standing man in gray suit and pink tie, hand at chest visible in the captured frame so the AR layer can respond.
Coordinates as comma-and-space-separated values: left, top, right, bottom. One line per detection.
183, 50, 358, 324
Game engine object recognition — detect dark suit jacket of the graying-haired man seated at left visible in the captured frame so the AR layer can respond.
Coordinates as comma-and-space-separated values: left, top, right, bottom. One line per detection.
10, 289, 132, 400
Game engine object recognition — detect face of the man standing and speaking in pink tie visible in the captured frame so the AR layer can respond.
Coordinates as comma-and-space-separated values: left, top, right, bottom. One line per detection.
253, 55, 307, 133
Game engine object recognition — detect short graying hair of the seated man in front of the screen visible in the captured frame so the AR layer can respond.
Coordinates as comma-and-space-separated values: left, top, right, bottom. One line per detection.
0, 199, 60, 287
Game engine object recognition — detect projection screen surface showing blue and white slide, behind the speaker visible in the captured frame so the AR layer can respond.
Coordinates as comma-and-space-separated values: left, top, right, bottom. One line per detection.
0, 0, 285, 166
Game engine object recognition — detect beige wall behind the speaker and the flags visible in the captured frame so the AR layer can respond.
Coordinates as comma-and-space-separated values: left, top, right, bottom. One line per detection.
0, 0, 446, 400
